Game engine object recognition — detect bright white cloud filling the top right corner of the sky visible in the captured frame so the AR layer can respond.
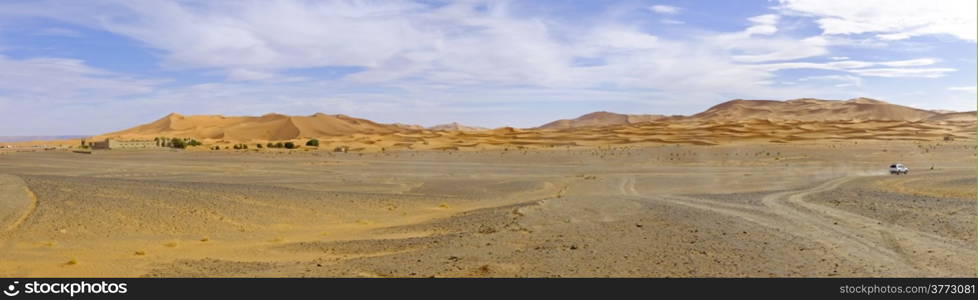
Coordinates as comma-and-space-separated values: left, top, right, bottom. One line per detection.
779, 0, 978, 42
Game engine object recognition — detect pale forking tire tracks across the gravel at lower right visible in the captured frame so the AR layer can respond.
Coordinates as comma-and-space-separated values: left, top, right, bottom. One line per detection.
619, 176, 974, 276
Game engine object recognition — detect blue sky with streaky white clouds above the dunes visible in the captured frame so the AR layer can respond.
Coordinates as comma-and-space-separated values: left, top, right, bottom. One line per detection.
0, 0, 978, 136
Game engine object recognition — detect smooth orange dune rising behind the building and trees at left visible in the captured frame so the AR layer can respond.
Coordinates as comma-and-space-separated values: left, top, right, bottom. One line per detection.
94, 113, 418, 141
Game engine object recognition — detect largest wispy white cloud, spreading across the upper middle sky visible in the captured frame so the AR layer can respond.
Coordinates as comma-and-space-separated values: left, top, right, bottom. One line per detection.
0, 1, 800, 89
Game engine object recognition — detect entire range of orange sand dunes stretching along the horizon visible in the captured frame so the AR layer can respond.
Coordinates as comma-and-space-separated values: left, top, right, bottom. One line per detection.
5, 98, 976, 152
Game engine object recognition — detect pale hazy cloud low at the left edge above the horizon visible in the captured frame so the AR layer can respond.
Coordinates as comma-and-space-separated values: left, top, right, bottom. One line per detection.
0, 55, 166, 135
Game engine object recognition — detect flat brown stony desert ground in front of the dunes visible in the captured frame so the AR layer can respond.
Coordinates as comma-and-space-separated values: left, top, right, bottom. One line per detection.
0, 140, 976, 277
